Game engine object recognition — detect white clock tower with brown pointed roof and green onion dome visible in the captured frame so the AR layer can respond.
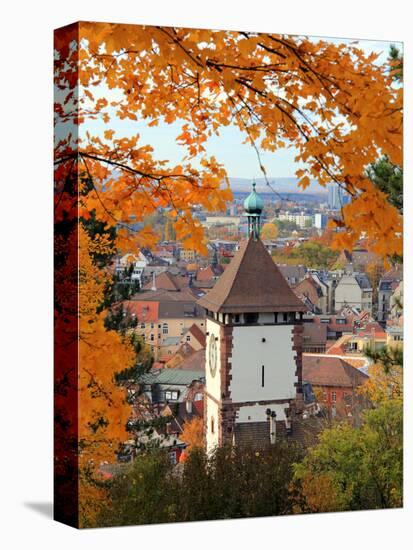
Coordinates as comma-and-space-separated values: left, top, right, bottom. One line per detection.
198, 184, 307, 451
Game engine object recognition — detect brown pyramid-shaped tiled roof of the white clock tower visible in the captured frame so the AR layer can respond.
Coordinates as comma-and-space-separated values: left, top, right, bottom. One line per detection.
198, 236, 307, 313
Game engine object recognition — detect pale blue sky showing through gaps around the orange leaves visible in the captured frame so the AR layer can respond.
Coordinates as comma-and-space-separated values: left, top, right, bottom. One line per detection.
82, 37, 402, 183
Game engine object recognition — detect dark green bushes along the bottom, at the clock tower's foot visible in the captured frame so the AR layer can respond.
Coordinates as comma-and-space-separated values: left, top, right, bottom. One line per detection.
100, 443, 303, 525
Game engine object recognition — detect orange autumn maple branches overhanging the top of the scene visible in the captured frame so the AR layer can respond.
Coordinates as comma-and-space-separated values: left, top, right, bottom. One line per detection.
55, 23, 403, 256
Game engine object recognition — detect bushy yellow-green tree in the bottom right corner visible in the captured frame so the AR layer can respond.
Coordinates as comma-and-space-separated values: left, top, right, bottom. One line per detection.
294, 399, 403, 512
